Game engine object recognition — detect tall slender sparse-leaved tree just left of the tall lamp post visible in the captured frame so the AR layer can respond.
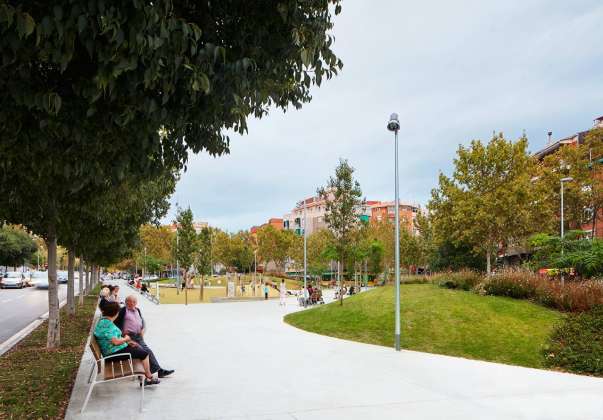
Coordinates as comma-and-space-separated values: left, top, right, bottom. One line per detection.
317, 159, 364, 305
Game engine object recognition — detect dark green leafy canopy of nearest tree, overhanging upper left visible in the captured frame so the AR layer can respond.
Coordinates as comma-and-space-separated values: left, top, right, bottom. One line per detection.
0, 0, 341, 191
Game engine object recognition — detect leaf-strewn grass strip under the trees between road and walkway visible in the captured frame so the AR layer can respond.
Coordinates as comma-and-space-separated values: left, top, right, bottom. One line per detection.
0, 290, 98, 419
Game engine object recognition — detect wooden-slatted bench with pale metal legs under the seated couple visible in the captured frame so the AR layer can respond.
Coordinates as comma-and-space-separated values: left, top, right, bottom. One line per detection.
81, 334, 145, 413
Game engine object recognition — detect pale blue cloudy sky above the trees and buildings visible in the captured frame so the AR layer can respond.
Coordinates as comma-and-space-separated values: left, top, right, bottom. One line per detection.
165, 0, 603, 232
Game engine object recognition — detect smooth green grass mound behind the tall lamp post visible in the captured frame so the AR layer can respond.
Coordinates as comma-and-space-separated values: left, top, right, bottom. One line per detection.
285, 284, 563, 368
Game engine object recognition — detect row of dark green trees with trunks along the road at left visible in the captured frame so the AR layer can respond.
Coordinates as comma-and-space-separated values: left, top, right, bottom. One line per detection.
0, 0, 342, 348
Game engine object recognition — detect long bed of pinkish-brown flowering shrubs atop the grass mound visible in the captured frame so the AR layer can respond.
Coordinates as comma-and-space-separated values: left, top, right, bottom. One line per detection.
480, 270, 603, 312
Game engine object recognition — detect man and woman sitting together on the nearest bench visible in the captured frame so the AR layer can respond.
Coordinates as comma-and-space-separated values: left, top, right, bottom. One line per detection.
94, 285, 174, 386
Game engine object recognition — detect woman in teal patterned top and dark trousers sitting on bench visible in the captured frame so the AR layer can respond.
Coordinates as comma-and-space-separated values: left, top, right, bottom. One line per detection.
94, 302, 159, 386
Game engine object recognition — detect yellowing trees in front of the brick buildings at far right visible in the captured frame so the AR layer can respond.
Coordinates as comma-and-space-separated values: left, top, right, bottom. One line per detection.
428, 128, 603, 272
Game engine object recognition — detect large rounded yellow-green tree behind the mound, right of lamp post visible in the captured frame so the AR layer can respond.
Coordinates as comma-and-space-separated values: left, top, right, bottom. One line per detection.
428, 134, 537, 273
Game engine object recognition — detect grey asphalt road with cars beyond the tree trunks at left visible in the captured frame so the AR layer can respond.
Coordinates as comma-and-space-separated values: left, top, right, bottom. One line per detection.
0, 280, 79, 344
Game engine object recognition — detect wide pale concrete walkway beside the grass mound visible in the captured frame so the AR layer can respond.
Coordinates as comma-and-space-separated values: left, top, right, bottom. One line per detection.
67, 282, 603, 420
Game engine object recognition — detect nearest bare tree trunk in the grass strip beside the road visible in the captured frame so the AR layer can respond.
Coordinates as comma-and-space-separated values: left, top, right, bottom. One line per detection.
46, 227, 61, 349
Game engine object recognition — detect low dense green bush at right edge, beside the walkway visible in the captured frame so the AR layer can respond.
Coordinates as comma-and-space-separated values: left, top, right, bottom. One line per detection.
544, 305, 603, 376
